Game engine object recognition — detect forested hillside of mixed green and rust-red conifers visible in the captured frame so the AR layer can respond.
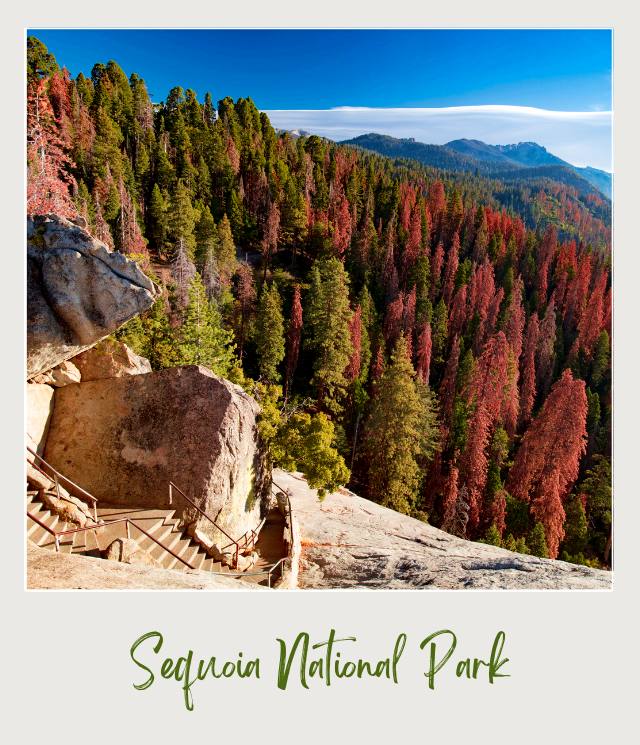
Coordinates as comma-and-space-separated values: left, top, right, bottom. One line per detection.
27, 38, 611, 566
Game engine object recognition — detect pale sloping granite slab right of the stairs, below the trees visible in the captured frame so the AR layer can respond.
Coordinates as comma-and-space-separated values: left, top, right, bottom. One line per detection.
274, 470, 611, 590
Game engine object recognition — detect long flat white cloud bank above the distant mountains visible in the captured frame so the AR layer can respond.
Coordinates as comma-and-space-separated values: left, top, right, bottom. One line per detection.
266, 105, 612, 171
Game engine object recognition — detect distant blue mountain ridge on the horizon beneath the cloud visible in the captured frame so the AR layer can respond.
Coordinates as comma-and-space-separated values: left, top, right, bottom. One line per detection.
340, 133, 612, 199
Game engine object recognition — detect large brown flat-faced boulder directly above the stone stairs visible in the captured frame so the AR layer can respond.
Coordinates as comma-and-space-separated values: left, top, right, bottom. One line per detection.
45, 366, 270, 549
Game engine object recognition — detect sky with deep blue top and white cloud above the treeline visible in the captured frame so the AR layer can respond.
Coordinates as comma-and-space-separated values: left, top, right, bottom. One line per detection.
30, 30, 611, 170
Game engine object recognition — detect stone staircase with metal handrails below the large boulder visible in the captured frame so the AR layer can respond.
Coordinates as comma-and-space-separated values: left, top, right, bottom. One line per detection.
27, 491, 230, 573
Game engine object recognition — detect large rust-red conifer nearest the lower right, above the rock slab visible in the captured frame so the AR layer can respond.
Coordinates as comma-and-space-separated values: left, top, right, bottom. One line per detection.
507, 370, 587, 559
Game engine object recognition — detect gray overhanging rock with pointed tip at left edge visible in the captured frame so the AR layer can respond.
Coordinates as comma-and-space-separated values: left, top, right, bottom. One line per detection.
27, 215, 157, 378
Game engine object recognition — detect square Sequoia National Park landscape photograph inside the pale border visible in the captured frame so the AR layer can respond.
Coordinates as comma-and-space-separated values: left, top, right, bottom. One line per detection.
26, 26, 616, 588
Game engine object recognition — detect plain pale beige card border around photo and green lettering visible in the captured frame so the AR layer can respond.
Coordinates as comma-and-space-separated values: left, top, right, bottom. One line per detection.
0, 0, 640, 745
